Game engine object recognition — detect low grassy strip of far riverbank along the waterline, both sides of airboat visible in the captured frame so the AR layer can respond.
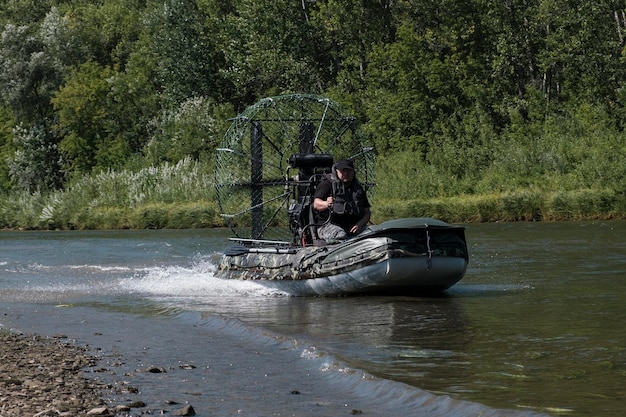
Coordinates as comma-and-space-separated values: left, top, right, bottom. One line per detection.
0, 189, 626, 230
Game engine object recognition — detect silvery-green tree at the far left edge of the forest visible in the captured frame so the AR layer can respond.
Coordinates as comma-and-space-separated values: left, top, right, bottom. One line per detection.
0, 8, 75, 190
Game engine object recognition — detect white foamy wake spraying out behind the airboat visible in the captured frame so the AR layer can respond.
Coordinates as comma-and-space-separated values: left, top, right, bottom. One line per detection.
0, 257, 287, 303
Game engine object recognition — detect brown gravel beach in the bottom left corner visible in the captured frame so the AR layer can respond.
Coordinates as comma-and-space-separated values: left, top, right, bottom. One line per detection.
0, 332, 108, 417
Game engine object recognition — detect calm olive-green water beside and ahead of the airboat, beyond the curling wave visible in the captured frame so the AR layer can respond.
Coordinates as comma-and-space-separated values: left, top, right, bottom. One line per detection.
210, 221, 626, 416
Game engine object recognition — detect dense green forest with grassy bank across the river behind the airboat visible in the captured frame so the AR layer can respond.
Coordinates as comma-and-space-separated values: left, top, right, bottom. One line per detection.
0, 0, 626, 228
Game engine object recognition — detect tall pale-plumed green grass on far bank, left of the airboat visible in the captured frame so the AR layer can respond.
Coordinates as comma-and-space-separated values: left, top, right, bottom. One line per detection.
0, 159, 221, 229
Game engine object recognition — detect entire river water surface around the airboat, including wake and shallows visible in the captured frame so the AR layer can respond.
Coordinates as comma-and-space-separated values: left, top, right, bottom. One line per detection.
0, 221, 626, 417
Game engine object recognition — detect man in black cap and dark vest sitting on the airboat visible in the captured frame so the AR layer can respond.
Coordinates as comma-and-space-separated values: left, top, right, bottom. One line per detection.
313, 159, 371, 241
